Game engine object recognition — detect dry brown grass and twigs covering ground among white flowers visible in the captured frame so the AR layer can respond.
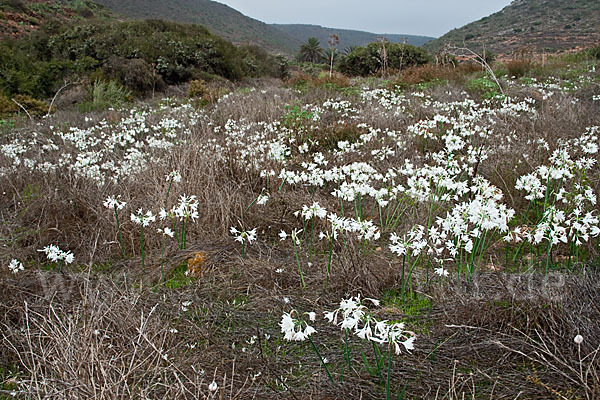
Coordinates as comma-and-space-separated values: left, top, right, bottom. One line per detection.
0, 62, 600, 399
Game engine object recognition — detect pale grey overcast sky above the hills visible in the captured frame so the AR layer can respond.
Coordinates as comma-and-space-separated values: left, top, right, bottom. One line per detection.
217, 0, 510, 37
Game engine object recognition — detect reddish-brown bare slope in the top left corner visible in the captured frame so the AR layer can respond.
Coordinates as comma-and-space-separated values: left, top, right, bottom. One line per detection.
0, 0, 110, 38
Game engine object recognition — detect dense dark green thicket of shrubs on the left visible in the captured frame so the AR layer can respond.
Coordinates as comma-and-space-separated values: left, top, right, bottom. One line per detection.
0, 20, 278, 97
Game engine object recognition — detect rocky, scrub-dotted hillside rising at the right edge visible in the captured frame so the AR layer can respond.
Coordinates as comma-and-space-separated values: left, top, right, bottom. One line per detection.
425, 0, 600, 54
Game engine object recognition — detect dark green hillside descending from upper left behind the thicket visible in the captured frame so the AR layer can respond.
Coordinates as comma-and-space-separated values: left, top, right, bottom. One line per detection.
90, 0, 300, 54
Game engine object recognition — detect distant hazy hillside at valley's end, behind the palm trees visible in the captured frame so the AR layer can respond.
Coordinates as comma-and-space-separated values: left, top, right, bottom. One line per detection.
272, 24, 435, 49
